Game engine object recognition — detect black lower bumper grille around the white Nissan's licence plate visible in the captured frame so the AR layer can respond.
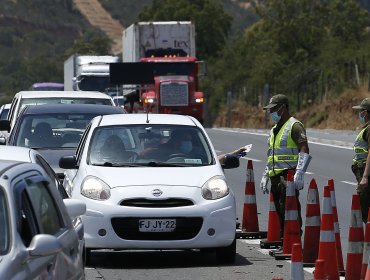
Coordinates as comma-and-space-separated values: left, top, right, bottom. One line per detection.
112, 217, 203, 240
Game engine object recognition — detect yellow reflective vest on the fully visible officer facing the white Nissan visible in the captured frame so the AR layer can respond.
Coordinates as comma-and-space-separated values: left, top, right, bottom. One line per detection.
267, 117, 303, 177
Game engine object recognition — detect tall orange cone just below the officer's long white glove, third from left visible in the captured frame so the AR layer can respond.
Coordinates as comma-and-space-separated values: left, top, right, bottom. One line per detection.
271, 170, 302, 260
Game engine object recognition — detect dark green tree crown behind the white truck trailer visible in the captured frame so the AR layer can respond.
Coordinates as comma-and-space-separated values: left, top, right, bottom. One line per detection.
137, 0, 232, 59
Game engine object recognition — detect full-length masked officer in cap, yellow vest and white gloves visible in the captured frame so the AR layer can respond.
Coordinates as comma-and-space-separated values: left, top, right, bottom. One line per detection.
260, 94, 311, 237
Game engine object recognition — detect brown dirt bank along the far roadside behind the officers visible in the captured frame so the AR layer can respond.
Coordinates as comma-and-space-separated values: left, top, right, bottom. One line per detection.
214, 88, 370, 130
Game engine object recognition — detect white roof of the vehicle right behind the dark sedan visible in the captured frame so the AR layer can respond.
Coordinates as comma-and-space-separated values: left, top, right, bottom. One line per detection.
15, 90, 111, 99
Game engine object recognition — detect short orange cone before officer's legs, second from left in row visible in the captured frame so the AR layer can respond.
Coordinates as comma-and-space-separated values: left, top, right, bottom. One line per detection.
260, 192, 282, 249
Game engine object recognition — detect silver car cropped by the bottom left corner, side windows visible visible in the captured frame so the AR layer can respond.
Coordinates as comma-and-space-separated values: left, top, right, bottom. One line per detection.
0, 160, 86, 280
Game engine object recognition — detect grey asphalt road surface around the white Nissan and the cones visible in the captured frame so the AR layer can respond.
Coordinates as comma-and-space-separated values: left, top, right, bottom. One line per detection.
85, 128, 356, 280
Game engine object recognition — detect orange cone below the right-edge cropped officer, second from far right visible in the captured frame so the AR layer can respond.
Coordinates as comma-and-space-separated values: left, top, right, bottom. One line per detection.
346, 194, 364, 280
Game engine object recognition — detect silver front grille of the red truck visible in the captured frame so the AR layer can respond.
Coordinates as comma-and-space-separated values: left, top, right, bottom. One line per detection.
160, 82, 189, 106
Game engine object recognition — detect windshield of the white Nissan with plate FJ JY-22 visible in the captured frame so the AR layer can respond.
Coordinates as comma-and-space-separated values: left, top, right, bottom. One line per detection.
89, 125, 214, 166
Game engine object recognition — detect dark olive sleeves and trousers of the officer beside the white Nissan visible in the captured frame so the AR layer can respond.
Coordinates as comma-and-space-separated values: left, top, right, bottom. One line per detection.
270, 122, 307, 237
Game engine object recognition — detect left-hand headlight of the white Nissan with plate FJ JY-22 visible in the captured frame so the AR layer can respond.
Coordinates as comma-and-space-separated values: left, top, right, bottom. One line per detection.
81, 176, 110, 200
